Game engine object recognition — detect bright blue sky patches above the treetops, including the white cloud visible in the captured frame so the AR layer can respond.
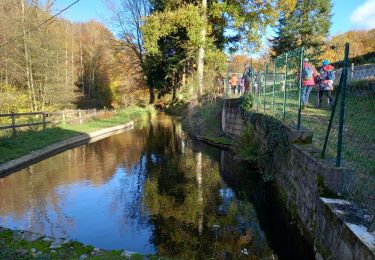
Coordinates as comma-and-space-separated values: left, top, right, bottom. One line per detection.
55, 0, 375, 35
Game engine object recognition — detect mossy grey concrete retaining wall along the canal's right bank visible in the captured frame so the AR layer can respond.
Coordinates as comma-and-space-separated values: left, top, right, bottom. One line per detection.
222, 99, 375, 260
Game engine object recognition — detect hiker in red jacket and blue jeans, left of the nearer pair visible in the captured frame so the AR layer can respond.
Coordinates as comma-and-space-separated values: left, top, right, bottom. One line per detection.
301, 58, 317, 108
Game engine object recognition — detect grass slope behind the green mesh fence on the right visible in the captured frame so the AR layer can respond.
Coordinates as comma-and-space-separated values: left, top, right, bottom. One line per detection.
254, 85, 375, 176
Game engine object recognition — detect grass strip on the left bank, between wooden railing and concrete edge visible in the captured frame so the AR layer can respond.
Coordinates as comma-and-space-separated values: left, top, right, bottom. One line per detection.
0, 107, 155, 163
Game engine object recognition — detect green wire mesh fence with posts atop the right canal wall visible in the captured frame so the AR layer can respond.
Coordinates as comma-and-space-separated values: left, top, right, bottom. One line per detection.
226, 44, 375, 177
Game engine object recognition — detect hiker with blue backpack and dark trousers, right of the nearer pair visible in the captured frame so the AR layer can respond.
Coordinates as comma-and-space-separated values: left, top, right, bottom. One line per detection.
317, 60, 335, 107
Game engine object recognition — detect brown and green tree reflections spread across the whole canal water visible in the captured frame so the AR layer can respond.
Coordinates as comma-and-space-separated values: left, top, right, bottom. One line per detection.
0, 116, 271, 259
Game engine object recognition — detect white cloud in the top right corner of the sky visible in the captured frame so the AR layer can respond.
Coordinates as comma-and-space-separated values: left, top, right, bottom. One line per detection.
350, 0, 375, 29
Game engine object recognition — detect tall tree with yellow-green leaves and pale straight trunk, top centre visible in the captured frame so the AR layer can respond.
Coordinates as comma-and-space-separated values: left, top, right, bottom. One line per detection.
142, 0, 295, 100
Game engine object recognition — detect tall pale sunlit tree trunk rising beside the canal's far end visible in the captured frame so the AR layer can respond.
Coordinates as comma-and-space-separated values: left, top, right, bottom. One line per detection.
197, 0, 207, 100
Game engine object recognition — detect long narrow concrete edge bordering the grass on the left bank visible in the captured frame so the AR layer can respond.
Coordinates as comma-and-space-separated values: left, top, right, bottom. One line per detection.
0, 121, 134, 177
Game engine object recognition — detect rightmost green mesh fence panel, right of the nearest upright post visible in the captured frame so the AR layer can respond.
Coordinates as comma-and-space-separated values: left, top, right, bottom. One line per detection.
342, 53, 375, 177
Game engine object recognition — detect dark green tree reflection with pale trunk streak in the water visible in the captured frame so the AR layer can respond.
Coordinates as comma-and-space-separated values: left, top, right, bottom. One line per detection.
143, 122, 272, 259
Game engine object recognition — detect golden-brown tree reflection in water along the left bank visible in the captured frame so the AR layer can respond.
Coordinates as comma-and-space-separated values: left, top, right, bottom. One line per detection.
0, 132, 145, 235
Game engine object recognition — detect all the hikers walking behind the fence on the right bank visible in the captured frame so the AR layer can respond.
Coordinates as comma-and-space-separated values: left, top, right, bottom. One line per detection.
229, 58, 335, 108
